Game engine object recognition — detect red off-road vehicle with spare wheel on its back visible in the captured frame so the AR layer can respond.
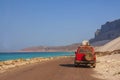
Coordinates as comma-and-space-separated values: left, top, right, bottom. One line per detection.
74, 45, 96, 68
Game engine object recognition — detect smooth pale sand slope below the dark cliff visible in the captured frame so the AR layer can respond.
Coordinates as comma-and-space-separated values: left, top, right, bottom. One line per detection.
96, 37, 120, 52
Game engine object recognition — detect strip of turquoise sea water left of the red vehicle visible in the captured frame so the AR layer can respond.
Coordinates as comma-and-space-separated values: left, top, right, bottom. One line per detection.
0, 52, 74, 61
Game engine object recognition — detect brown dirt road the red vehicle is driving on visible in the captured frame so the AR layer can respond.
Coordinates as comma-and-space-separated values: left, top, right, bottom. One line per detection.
0, 58, 99, 80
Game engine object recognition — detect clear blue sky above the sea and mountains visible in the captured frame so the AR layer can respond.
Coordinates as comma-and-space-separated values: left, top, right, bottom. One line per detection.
0, 0, 120, 51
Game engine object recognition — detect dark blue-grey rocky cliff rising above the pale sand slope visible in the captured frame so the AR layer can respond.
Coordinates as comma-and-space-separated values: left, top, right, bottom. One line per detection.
90, 19, 120, 43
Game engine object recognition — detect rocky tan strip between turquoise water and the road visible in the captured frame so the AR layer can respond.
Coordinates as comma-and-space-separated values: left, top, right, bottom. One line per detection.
0, 55, 72, 73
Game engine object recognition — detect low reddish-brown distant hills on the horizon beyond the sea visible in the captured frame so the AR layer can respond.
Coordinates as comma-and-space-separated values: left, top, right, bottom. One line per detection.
20, 43, 80, 52
